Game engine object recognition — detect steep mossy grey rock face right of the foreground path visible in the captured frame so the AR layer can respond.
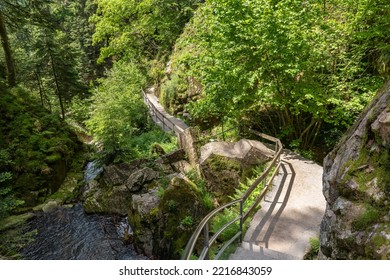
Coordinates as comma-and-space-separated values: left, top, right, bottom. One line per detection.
319, 82, 390, 259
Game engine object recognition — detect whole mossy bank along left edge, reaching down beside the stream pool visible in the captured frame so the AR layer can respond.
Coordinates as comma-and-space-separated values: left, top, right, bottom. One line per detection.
0, 87, 85, 258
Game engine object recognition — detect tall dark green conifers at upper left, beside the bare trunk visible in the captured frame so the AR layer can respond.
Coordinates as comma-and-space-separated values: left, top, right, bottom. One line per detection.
11, 0, 94, 117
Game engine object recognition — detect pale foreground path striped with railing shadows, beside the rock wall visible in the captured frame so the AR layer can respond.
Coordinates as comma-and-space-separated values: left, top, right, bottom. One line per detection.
230, 151, 326, 260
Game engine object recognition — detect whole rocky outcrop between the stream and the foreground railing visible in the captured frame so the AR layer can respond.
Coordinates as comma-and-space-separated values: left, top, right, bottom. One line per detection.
82, 129, 272, 259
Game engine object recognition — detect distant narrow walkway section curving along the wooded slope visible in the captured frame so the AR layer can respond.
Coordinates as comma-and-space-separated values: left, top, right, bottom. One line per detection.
144, 88, 188, 134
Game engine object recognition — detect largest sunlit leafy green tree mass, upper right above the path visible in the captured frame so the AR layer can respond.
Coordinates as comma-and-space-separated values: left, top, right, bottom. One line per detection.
163, 0, 389, 149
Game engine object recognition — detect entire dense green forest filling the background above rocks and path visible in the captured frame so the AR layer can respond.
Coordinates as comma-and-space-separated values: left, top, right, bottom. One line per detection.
0, 0, 390, 257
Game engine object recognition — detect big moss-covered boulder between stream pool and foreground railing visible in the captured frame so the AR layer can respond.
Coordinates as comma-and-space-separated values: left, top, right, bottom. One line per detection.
128, 176, 206, 259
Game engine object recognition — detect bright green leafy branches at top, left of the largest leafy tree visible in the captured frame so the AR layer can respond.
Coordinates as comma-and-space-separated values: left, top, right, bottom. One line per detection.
91, 0, 199, 62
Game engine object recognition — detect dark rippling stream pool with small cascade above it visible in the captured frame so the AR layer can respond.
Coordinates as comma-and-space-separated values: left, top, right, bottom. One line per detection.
21, 164, 146, 260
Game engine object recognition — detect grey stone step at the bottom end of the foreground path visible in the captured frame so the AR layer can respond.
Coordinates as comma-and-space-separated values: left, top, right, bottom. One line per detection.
229, 241, 299, 260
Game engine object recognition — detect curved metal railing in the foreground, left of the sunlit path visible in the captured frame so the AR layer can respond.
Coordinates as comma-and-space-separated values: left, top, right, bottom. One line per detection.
182, 129, 283, 260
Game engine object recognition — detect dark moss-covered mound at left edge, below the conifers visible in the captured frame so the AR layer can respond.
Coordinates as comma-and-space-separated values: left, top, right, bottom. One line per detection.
0, 88, 83, 207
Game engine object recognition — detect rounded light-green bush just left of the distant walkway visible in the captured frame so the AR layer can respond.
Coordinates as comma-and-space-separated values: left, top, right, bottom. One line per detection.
86, 63, 148, 158
